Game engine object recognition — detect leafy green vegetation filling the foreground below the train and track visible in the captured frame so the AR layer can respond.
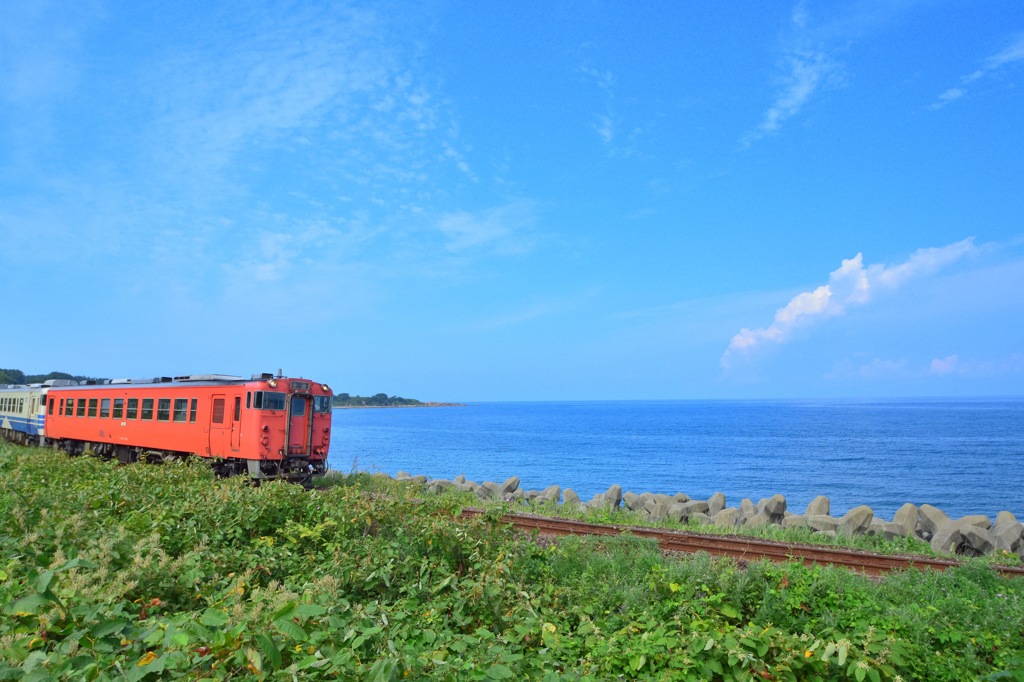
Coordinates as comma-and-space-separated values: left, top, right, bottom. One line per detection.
0, 445, 1024, 682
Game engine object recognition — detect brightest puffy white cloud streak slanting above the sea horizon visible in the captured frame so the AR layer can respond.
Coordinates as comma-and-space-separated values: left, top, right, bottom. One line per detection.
721, 238, 978, 369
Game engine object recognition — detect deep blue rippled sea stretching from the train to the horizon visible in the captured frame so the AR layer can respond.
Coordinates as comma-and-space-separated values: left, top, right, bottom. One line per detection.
330, 398, 1024, 520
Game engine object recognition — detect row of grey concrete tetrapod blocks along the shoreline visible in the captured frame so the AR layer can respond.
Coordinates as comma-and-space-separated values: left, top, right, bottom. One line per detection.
385, 471, 1024, 559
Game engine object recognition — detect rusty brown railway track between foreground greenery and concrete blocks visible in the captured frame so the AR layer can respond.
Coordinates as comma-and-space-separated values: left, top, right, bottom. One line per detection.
462, 508, 1024, 577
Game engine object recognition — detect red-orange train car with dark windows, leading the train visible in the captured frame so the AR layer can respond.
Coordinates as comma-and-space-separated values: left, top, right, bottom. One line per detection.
45, 374, 333, 481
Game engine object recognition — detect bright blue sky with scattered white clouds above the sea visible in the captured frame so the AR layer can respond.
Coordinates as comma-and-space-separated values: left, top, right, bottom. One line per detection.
0, 0, 1024, 400
